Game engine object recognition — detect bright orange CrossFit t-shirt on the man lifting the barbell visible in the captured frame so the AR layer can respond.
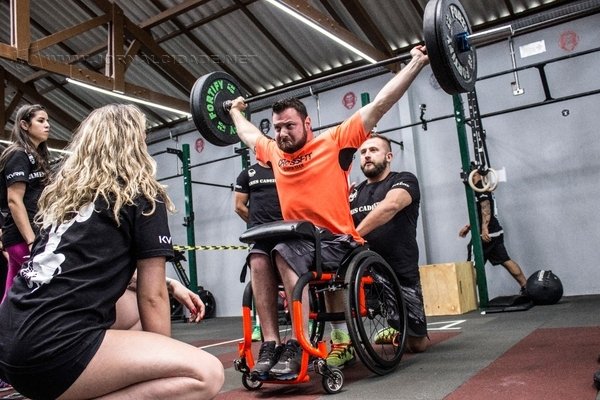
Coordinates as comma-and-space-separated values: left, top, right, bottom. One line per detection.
255, 113, 369, 243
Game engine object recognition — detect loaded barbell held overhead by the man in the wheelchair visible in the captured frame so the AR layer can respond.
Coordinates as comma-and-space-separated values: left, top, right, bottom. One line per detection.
190, 0, 514, 146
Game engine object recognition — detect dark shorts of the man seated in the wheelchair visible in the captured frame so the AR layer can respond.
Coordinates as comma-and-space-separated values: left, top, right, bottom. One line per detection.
272, 235, 359, 276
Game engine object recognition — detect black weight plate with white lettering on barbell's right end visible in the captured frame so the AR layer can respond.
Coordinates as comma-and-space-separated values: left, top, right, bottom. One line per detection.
423, 0, 477, 94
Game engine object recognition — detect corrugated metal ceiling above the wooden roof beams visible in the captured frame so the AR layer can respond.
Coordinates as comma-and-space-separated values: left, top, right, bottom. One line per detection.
0, 0, 596, 148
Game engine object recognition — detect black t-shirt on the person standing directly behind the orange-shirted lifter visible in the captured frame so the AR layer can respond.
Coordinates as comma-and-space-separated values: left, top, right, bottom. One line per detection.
235, 163, 283, 227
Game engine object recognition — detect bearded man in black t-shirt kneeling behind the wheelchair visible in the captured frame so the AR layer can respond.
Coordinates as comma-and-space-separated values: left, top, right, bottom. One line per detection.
344, 135, 428, 365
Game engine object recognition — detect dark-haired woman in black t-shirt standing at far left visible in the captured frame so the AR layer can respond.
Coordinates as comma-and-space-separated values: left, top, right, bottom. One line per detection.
0, 104, 50, 300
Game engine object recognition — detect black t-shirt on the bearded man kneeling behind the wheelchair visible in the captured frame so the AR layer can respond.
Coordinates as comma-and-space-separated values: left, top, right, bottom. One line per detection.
350, 172, 421, 283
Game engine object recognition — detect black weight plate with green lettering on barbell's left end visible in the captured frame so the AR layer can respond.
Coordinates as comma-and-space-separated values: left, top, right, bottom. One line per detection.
190, 72, 249, 146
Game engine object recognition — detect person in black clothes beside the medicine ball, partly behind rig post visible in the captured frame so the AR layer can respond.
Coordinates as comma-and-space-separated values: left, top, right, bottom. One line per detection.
458, 171, 527, 296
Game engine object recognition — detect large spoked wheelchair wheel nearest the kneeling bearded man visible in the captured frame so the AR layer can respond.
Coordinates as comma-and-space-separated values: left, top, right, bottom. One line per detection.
345, 250, 406, 375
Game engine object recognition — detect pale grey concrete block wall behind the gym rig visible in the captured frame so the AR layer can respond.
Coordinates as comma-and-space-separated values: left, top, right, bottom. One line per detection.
151, 15, 600, 316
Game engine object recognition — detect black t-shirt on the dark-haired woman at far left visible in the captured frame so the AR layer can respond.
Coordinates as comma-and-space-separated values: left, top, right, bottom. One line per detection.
0, 150, 46, 247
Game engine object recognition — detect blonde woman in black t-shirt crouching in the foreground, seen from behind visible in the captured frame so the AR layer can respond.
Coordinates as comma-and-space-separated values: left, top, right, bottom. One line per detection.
0, 105, 224, 400
